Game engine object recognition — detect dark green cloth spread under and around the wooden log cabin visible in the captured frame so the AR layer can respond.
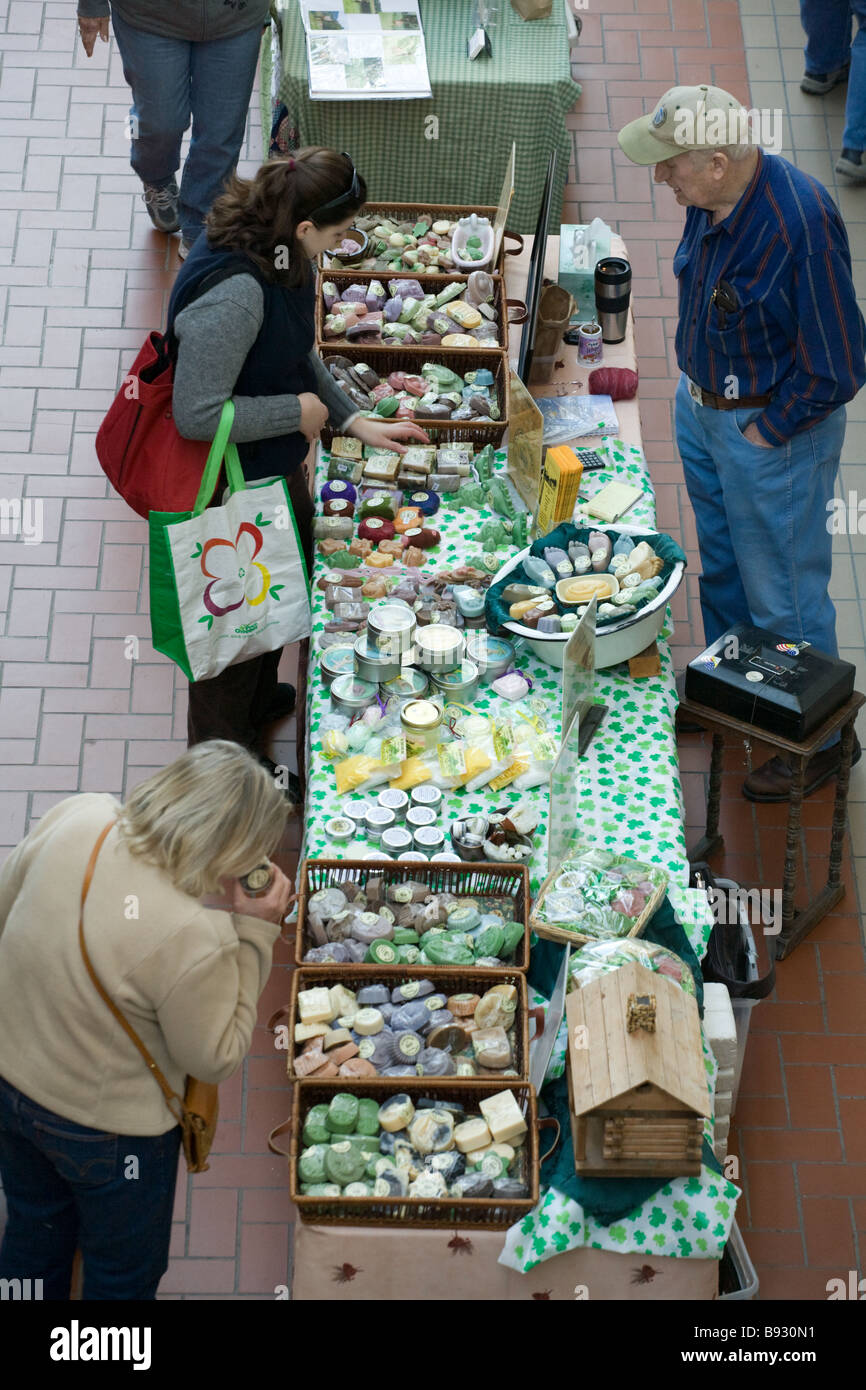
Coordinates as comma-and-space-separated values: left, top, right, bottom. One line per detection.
528, 898, 721, 1226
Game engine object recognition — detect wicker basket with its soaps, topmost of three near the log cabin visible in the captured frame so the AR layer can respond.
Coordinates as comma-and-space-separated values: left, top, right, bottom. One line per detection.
295, 859, 530, 967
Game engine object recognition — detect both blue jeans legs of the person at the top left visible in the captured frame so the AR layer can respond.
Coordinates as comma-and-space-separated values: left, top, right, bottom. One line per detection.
111, 10, 261, 242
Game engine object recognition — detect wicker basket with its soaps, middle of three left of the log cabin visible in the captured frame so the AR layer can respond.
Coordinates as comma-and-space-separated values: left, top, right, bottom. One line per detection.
279, 966, 544, 1086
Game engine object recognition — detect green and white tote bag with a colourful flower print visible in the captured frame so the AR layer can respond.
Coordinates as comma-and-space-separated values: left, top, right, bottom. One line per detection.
149, 400, 311, 681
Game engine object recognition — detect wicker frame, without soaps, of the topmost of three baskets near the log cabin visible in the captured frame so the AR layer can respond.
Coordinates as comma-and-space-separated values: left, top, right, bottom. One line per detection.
295, 859, 530, 967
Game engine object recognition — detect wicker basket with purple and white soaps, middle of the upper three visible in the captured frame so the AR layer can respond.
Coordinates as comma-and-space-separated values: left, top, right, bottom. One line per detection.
316, 270, 527, 360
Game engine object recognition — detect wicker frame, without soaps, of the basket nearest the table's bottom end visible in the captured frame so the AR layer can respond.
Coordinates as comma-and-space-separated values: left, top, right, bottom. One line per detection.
268, 1077, 559, 1230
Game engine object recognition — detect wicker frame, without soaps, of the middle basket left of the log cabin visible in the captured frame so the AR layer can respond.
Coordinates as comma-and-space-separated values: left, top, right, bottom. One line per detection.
280, 965, 545, 1088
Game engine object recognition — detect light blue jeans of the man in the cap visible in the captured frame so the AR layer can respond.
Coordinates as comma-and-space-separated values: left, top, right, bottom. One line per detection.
677, 377, 845, 656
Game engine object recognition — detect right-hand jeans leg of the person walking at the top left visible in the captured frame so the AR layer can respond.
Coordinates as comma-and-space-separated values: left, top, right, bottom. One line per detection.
179, 28, 261, 246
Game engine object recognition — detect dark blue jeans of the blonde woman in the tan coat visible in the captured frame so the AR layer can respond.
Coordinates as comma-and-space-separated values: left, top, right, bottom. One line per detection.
0, 1077, 181, 1301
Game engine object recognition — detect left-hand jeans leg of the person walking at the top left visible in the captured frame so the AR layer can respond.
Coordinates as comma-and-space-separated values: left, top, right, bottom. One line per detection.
111, 10, 195, 232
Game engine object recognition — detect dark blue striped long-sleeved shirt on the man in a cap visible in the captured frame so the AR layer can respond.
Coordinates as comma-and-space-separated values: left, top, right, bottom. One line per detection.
674, 150, 866, 445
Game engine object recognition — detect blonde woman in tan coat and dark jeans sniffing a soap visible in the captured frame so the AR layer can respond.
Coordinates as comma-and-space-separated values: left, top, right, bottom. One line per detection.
0, 741, 292, 1300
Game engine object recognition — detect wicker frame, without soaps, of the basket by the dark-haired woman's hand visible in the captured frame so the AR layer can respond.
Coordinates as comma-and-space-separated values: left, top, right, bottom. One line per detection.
317, 343, 509, 449
